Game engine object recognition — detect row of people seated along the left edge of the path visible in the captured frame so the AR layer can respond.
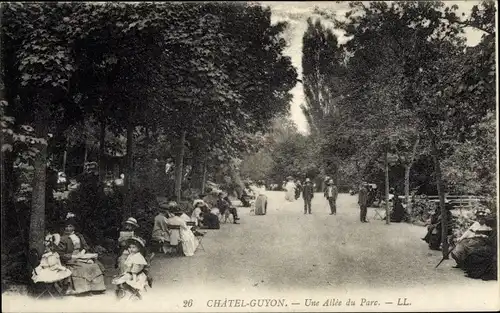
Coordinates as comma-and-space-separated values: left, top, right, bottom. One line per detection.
32, 192, 243, 299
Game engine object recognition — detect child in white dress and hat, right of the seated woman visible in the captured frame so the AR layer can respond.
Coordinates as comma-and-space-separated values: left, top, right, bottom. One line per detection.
112, 237, 148, 299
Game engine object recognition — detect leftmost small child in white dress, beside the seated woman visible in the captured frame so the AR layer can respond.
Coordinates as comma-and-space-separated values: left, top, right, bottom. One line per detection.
31, 234, 71, 283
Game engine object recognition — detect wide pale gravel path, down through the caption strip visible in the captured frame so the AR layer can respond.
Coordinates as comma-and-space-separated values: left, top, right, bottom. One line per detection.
2, 192, 499, 312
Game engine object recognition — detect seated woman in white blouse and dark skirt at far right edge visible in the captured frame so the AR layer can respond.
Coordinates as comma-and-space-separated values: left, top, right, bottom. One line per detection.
451, 210, 493, 268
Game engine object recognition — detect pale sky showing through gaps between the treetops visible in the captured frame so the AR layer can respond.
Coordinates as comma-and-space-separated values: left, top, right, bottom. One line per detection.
260, 1, 488, 133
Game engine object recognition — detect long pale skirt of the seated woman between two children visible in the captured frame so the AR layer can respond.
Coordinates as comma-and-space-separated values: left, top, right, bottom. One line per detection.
66, 261, 106, 294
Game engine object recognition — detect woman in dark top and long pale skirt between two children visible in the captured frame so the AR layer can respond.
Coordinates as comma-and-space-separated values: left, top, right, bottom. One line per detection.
57, 218, 106, 295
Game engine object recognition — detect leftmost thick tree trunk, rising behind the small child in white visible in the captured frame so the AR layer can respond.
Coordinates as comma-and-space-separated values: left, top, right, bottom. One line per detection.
29, 109, 48, 253
